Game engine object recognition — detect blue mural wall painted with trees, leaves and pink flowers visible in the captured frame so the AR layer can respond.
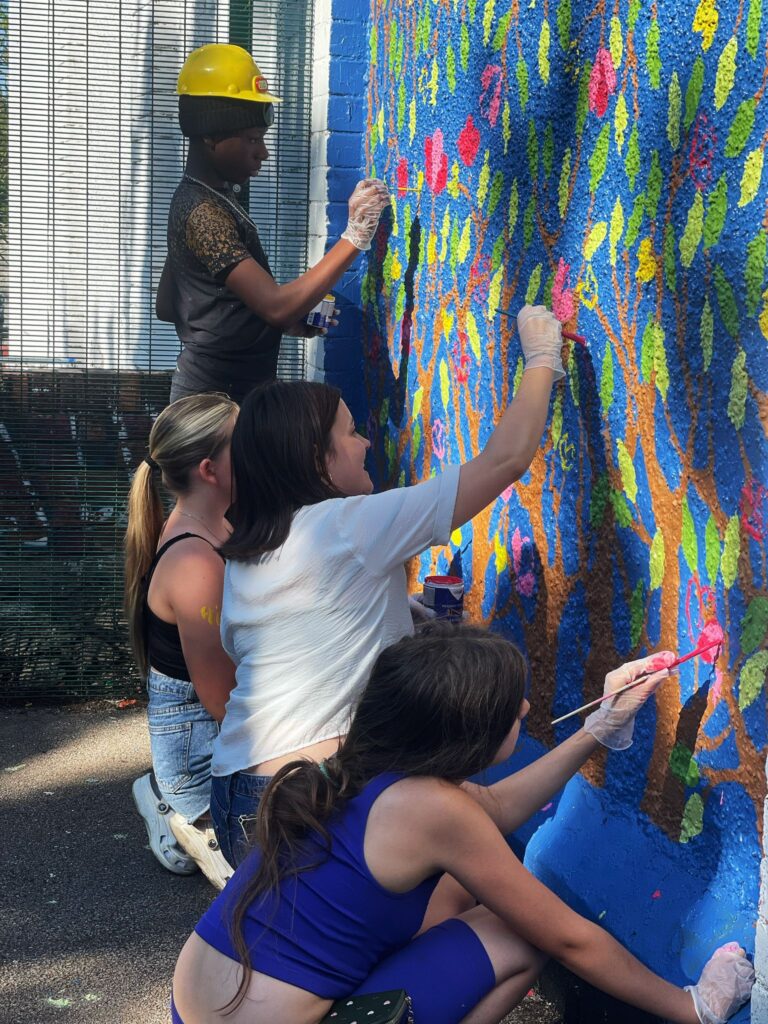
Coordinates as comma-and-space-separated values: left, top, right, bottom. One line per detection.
361, 0, 768, 1007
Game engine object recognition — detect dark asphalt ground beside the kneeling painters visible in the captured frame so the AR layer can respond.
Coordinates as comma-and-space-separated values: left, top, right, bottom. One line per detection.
0, 703, 561, 1024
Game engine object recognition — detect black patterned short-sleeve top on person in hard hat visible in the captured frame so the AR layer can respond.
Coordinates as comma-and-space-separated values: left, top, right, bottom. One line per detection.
168, 177, 282, 401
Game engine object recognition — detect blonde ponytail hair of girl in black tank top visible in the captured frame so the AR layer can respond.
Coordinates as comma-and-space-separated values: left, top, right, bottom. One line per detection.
124, 394, 238, 675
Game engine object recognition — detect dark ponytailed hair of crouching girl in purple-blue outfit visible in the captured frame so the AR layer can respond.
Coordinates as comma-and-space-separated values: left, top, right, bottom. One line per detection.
227, 622, 526, 1009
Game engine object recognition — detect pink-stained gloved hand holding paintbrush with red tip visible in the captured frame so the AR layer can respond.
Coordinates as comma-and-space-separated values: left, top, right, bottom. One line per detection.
584, 650, 675, 751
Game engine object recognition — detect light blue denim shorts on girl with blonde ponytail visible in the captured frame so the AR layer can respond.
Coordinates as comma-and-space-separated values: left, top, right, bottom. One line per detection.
146, 669, 219, 821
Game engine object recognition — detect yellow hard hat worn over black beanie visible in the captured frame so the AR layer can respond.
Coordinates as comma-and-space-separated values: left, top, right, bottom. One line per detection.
176, 43, 283, 103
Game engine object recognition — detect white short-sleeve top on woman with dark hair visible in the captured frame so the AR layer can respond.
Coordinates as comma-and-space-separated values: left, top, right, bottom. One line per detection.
211, 466, 460, 775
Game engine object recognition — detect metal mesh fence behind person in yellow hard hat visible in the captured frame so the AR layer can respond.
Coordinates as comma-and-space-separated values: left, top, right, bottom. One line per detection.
0, 0, 312, 699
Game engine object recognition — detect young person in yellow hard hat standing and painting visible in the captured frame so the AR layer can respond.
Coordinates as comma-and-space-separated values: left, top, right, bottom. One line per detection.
157, 43, 389, 401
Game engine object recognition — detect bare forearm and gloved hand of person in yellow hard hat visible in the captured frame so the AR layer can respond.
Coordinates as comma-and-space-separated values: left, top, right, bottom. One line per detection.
225, 178, 389, 330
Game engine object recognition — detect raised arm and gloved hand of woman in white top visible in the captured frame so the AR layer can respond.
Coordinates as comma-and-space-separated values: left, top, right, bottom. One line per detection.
452, 306, 564, 529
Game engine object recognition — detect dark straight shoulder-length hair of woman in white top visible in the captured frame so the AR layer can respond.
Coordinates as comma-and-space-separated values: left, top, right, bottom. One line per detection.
221, 381, 342, 561
